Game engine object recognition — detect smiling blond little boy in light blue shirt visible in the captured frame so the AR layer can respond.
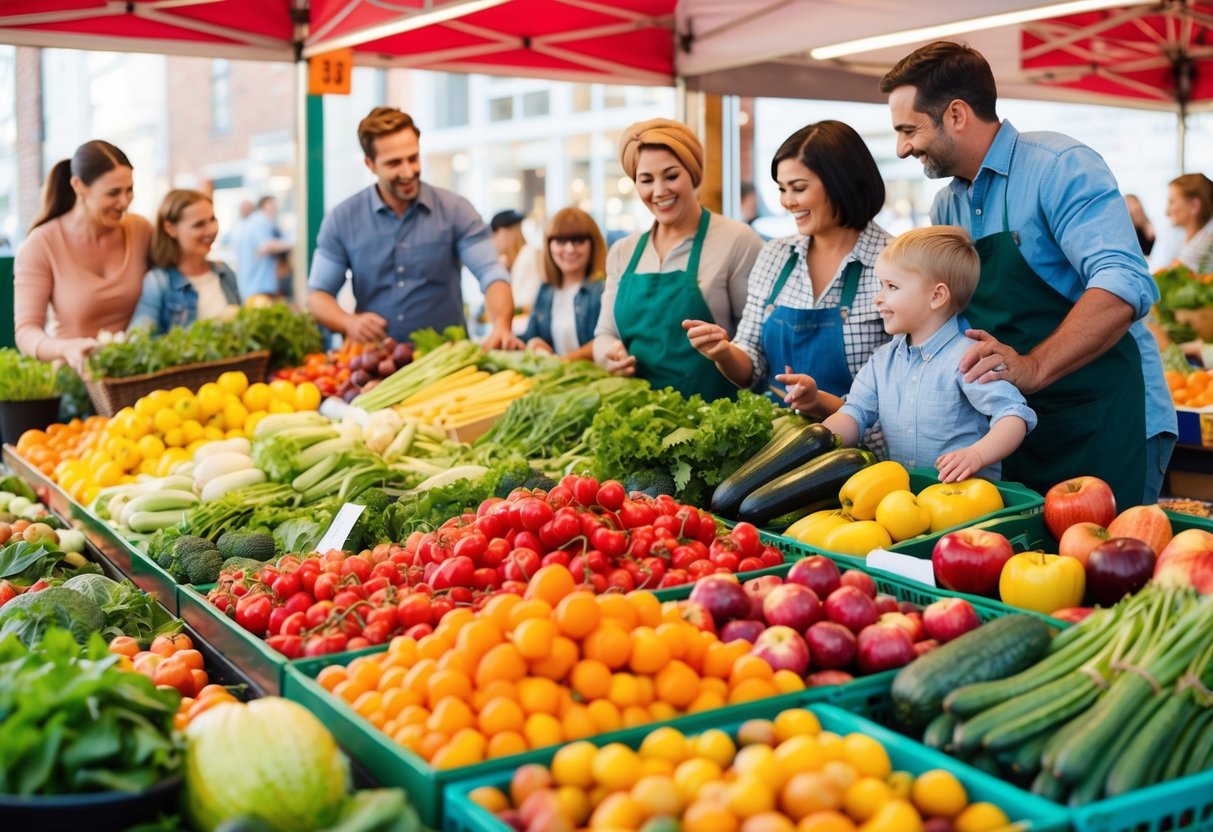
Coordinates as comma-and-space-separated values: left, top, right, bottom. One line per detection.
822, 226, 1036, 483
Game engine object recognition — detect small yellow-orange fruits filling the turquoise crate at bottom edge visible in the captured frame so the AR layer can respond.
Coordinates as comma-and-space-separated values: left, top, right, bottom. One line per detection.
471, 708, 1014, 832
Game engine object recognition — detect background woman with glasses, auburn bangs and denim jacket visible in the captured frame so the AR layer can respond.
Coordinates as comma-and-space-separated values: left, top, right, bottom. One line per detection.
523, 207, 607, 360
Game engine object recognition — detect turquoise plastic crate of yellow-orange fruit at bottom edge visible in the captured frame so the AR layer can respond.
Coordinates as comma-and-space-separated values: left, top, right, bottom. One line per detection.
443, 700, 1070, 832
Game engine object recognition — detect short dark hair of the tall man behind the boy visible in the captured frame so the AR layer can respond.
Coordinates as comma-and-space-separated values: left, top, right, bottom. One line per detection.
881, 40, 998, 125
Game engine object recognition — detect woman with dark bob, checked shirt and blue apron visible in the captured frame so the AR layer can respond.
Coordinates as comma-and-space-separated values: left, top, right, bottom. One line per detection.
684, 121, 890, 416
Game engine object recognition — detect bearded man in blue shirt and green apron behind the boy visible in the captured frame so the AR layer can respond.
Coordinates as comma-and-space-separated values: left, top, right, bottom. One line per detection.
881, 41, 1177, 507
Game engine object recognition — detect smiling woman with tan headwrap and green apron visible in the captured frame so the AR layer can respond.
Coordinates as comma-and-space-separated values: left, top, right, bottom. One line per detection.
594, 119, 762, 400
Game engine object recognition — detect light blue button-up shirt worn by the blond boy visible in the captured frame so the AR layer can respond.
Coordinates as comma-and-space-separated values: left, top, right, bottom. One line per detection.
838, 315, 1036, 479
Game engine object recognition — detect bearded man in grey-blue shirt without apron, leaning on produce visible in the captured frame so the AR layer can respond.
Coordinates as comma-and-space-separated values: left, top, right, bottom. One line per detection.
308, 107, 523, 349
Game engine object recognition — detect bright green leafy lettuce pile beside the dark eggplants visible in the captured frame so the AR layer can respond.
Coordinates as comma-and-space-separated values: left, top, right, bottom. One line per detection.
586, 388, 779, 505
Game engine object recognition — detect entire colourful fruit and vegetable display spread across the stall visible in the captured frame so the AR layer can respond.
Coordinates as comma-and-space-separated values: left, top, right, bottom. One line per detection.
0, 303, 1213, 830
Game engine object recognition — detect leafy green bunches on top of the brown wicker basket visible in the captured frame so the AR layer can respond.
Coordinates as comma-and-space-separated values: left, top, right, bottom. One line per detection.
89, 303, 323, 378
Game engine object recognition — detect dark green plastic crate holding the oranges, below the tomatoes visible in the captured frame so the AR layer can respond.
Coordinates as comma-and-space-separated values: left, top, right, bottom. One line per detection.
283, 656, 853, 828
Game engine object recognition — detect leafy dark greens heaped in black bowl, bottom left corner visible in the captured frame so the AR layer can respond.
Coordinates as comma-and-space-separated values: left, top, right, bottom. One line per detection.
0, 630, 181, 794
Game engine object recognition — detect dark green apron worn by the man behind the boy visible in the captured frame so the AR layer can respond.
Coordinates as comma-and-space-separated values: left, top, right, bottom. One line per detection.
964, 194, 1145, 508
